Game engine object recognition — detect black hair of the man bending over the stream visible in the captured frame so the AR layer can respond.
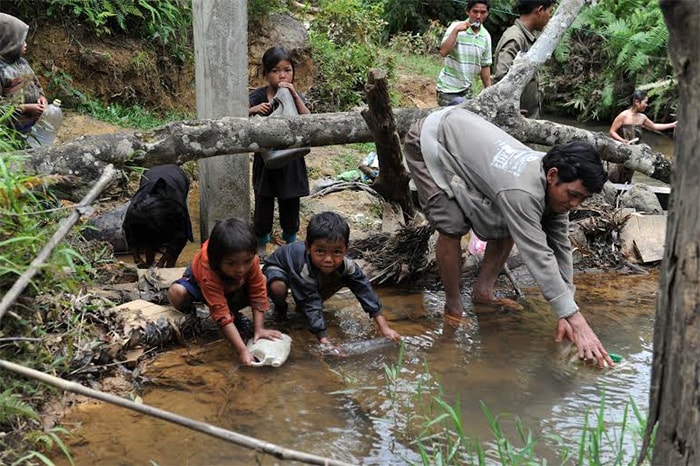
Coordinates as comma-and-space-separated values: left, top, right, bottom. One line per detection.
542, 141, 608, 193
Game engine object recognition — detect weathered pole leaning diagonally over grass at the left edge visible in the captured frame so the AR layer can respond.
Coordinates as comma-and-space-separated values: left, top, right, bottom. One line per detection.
0, 164, 117, 321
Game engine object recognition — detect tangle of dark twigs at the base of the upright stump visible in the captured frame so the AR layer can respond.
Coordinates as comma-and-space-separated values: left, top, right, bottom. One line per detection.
349, 223, 434, 284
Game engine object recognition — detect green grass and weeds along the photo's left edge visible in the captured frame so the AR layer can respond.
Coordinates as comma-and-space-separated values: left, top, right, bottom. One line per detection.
0, 142, 111, 464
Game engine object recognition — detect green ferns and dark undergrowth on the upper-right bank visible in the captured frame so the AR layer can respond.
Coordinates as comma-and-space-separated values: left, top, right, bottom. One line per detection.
540, 0, 678, 121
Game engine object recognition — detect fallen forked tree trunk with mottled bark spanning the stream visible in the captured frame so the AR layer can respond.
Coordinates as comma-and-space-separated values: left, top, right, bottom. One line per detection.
20, 0, 672, 197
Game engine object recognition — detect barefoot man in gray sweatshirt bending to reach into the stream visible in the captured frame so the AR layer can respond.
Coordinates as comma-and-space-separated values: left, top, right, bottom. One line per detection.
404, 108, 613, 367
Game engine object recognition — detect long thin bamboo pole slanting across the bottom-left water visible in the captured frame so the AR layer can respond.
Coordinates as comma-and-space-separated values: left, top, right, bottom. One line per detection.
0, 359, 351, 466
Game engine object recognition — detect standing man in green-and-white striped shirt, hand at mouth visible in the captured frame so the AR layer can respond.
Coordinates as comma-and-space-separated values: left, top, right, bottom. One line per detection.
436, 0, 492, 106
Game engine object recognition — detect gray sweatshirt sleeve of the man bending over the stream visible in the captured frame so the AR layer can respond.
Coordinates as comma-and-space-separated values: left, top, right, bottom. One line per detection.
496, 190, 579, 319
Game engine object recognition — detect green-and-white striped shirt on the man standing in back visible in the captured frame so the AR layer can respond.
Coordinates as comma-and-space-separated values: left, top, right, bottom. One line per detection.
437, 21, 492, 94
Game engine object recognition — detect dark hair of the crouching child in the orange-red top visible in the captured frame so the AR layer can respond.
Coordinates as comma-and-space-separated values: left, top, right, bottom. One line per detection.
207, 217, 258, 272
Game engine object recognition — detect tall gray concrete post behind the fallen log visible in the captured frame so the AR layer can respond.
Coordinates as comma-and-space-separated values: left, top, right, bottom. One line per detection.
192, 0, 250, 242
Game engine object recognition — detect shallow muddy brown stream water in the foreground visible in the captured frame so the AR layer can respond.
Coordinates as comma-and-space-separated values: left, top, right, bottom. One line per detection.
54, 123, 668, 465
